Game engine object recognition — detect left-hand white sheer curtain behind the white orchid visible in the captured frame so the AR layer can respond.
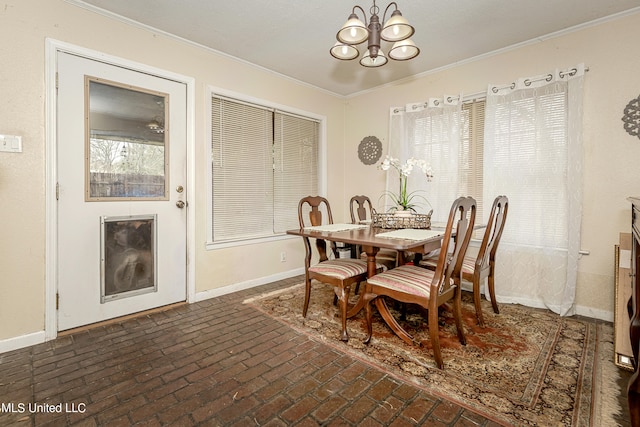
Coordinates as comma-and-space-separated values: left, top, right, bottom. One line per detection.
387, 95, 462, 222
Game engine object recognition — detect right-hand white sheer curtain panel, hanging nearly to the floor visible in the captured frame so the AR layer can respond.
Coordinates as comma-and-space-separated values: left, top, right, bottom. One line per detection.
483, 64, 584, 316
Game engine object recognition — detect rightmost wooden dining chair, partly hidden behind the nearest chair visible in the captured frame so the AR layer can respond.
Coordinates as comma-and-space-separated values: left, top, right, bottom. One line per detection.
420, 196, 509, 327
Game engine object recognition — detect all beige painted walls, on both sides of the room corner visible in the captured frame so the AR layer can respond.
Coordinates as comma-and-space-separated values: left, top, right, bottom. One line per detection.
0, 0, 640, 348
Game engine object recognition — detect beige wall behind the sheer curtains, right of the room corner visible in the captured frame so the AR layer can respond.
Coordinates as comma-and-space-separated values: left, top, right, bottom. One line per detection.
345, 14, 640, 319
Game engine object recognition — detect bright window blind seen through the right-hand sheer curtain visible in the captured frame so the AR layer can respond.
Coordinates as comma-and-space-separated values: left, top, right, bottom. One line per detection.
485, 90, 568, 249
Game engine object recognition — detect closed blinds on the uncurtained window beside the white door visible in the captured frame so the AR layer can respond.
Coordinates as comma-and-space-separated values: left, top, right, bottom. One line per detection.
211, 95, 319, 243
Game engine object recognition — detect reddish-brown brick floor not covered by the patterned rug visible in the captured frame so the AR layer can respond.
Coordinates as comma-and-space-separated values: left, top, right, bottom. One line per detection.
0, 277, 632, 427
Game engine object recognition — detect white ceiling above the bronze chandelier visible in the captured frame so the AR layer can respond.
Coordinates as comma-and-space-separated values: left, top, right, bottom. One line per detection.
66, 0, 640, 96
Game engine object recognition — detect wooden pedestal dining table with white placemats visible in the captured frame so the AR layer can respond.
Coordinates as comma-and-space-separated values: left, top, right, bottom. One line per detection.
287, 223, 456, 342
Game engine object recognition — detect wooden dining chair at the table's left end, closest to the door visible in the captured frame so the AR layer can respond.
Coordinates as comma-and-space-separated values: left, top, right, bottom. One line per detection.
298, 196, 386, 341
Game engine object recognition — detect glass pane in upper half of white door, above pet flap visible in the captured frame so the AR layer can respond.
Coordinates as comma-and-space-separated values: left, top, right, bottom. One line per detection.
85, 77, 169, 201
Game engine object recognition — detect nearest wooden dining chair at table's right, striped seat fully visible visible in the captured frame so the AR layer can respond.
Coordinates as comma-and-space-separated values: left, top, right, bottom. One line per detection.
363, 197, 476, 369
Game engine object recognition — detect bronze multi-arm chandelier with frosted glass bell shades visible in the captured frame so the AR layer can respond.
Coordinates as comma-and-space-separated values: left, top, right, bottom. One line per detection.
330, 0, 420, 67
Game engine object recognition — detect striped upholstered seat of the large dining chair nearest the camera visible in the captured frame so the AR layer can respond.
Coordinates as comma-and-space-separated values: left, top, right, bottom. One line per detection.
368, 265, 434, 298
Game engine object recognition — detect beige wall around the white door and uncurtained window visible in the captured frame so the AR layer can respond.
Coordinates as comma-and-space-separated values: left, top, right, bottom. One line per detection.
0, 0, 344, 344
